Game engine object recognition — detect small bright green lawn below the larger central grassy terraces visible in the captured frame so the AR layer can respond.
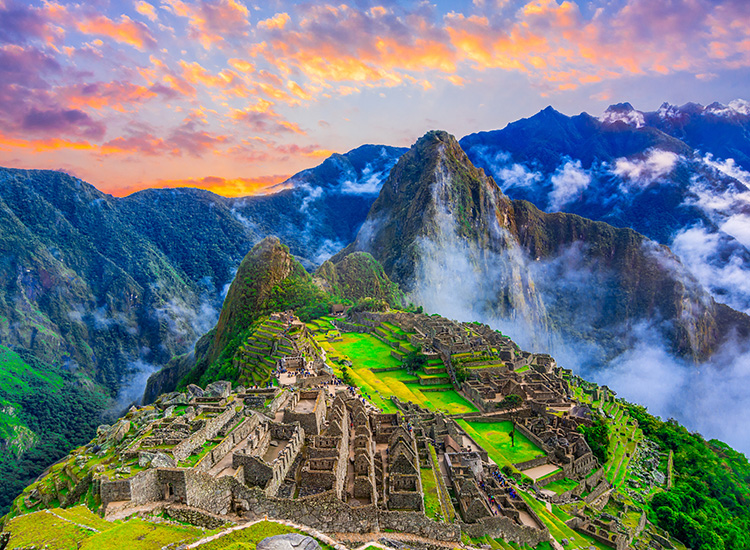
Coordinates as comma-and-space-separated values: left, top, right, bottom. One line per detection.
458, 419, 544, 467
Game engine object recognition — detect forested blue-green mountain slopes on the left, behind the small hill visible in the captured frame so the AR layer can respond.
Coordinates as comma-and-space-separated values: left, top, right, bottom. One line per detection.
0, 145, 403, 510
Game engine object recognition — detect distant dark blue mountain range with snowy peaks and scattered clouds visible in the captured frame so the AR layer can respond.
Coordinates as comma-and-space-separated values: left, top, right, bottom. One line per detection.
460, 101, 750, 312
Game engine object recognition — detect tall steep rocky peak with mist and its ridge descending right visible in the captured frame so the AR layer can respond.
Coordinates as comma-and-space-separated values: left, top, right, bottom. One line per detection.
340, 132, 750, 363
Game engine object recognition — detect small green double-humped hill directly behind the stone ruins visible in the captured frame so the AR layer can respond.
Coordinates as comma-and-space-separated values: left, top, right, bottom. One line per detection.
143, 236, 402, 403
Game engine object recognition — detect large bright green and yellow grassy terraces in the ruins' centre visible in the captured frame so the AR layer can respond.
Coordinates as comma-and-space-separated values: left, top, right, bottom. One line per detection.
308, 324, 478, 414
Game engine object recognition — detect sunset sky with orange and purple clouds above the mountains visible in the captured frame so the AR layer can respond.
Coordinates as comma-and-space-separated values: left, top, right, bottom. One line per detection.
0, 0, 750, 196
